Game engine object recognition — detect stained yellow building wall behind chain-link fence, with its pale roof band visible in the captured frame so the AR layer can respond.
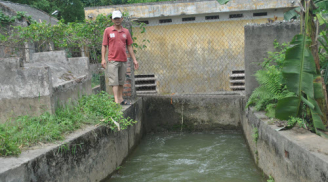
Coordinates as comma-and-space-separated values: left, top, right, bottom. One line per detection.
85, 0, 295, 94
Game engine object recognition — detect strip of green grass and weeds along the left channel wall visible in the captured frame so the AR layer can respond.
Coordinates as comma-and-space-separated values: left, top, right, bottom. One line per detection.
0, 92, 136, 156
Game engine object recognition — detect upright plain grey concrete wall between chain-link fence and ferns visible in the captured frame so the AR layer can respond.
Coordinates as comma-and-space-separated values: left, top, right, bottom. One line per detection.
245, 22, 300, 98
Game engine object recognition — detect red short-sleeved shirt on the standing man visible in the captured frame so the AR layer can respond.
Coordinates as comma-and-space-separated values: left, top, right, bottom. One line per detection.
102, 26, 133, 62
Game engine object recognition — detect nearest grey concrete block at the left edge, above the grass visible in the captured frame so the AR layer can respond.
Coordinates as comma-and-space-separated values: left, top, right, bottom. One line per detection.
0, 58, 52, 123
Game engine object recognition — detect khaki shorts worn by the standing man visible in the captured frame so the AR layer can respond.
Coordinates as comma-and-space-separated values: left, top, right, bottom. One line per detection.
107, 61, 126, 86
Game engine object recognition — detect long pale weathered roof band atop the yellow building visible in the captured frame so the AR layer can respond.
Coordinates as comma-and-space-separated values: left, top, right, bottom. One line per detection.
85, 0, 296, 19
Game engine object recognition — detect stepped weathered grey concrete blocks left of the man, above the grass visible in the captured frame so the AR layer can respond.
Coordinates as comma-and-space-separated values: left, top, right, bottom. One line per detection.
0, 51, 92, 123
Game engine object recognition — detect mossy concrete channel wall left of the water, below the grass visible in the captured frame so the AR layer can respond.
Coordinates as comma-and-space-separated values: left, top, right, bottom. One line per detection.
0, 99, 143, 182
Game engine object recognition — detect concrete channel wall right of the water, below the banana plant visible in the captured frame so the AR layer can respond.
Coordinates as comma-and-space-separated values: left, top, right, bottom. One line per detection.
243, 109, 328, 182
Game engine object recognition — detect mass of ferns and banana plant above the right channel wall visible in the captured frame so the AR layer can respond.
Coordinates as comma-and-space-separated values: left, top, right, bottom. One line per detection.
247, 0, 328, 136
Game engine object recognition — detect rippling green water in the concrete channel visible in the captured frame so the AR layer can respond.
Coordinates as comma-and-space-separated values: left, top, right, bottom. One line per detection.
107, 132, 266, 182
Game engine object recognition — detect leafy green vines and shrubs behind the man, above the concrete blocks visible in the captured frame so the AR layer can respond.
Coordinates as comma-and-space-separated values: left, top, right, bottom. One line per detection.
0, 13, 149, 63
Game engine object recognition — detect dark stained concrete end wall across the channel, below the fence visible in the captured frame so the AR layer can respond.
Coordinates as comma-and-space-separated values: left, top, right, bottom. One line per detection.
143, 95, 244, 133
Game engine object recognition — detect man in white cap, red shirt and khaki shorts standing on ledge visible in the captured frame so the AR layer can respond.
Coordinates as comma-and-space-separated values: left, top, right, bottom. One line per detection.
101, 11, 139, 105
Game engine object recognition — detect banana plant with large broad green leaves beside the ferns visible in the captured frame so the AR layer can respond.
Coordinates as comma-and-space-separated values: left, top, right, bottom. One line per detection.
276, 1, 326, 136
